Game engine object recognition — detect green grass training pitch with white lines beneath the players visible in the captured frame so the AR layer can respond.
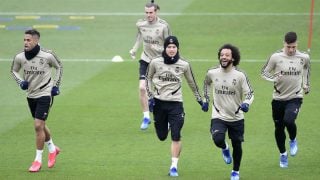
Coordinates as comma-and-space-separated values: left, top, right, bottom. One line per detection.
0, 0, 320, 180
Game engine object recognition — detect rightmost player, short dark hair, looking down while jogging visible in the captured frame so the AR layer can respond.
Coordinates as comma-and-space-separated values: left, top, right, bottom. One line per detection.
261, 32, 310, 168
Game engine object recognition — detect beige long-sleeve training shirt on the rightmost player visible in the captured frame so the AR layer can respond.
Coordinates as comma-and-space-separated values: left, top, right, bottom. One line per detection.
261, 50, 310, 100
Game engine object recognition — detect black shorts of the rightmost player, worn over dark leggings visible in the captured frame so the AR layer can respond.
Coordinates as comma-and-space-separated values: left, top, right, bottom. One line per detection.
271, 98, 302, 121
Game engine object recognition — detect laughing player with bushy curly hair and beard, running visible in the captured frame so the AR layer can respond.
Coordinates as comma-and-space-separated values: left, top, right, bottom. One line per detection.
202, 44, 254, 180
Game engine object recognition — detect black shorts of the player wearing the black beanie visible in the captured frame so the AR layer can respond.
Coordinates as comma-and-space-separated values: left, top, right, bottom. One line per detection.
153, 99, 185, 141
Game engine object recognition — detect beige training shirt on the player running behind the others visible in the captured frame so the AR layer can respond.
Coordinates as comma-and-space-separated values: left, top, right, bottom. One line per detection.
133, 17, 171, 63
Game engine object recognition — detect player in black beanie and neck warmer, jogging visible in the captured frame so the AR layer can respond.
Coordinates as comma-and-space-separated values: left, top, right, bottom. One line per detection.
147, 36, 202, 176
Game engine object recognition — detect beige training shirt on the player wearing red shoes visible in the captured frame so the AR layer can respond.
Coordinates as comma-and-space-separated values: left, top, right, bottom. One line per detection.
11, 48, 62, 98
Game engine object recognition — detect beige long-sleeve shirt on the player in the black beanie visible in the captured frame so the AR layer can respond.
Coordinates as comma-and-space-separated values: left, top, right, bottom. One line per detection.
147, 57, 201, 102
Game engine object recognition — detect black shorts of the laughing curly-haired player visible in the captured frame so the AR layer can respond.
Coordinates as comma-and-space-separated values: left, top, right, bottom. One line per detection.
210, 119, 244, 142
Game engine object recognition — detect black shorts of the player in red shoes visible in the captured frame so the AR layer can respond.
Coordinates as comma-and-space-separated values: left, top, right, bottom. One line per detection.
27, 96, 53, 121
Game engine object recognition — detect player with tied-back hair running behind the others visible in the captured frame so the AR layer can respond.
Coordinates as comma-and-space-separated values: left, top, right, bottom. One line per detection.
130, 1, 171, 130
